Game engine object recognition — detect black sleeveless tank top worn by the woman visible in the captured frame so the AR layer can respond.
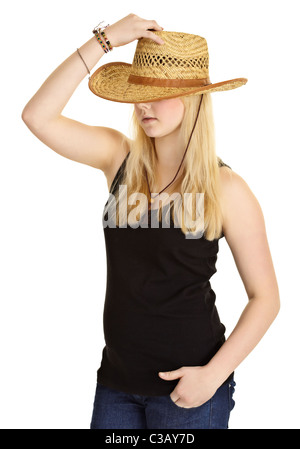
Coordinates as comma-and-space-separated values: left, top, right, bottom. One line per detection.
97, 153, 230, 396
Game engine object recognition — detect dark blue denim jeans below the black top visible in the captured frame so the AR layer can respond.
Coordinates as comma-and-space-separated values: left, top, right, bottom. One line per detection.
91, 380, 235, 429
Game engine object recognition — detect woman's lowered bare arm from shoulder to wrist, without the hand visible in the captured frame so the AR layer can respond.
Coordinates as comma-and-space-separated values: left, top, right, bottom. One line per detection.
208, 166, 280, 384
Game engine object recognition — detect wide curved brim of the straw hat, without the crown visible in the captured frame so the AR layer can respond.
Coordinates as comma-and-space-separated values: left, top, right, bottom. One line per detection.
89, 62, 248, 103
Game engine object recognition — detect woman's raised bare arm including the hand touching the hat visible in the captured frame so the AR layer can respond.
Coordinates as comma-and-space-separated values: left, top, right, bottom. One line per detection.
22, 14, 161, 172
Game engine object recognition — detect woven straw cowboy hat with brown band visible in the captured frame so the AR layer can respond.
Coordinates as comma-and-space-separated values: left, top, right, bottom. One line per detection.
89, 31, 248, 103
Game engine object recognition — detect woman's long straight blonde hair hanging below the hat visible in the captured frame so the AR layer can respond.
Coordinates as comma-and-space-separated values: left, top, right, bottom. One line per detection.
109, 93, 226, 240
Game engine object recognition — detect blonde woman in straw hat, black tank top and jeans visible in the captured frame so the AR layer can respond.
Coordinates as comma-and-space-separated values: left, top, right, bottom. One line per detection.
22, 14, 280, 429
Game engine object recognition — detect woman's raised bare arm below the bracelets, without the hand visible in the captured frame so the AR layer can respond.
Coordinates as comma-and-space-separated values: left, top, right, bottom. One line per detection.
22, 37, 118, 169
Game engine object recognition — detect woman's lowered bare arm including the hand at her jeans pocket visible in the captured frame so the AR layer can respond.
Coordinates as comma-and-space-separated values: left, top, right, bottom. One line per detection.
159, 167, 280, 408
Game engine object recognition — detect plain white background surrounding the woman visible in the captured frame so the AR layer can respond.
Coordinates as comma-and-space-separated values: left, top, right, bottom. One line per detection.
0, 0, 300, 429
